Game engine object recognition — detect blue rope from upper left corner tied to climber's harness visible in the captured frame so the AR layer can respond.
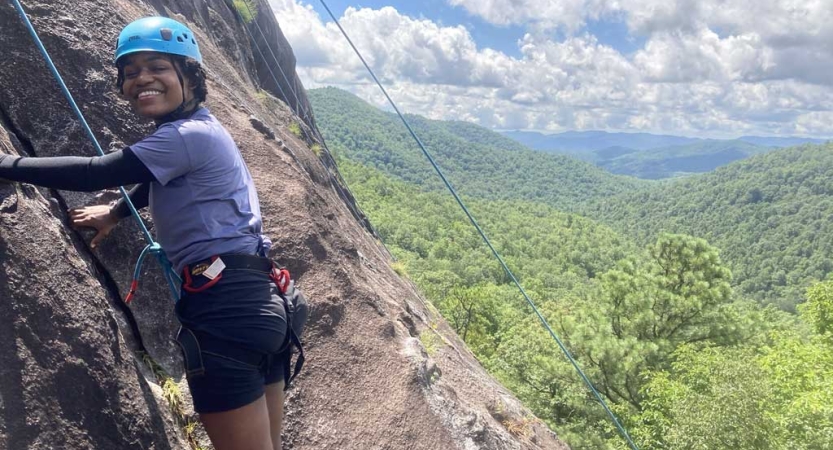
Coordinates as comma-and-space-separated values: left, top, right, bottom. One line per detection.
12, 0, 180, 303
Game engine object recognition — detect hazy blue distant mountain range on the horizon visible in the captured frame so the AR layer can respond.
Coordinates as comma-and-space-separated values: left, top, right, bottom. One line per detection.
503, 131, 827, 179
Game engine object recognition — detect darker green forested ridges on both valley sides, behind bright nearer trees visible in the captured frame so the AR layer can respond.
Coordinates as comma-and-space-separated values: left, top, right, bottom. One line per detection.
310, 88, 833, 311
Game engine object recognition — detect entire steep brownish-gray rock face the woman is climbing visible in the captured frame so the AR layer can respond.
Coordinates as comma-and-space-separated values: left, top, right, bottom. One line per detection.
0, 0, 563, 450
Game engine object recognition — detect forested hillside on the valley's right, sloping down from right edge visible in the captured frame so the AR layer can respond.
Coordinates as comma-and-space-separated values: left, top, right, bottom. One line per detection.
587, 144, 833, 310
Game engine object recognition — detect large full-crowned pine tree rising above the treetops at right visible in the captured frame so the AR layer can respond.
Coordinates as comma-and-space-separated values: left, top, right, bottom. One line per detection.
565, 235, 738, 409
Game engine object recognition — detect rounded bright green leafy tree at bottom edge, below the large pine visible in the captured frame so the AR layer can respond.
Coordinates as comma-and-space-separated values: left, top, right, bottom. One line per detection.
631, 345, 785, 450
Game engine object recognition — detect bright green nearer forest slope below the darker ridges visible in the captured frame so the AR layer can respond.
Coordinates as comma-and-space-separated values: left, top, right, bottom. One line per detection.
341, 161, 833, 450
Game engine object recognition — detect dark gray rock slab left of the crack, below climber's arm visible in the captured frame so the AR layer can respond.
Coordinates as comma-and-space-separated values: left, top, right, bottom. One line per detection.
0, 125, 187, 449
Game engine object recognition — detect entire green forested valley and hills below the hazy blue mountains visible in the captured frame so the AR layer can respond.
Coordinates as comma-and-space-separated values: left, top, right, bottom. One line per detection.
309, 88, 833, 449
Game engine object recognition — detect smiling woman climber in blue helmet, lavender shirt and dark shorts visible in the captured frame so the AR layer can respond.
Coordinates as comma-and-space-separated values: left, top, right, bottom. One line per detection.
0, 17, 298, 450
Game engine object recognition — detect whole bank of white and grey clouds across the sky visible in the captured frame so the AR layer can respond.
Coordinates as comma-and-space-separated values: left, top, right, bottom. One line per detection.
270, 0, 833, 137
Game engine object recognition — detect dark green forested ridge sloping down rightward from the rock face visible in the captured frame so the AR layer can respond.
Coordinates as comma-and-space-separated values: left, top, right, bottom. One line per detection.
309, 88, 644, 211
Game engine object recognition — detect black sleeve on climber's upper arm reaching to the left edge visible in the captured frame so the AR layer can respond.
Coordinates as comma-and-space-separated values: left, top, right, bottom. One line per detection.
0, 148, 155, 192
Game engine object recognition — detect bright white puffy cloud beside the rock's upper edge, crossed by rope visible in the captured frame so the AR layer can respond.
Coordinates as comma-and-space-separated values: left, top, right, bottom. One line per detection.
271, 0, 513, 87
